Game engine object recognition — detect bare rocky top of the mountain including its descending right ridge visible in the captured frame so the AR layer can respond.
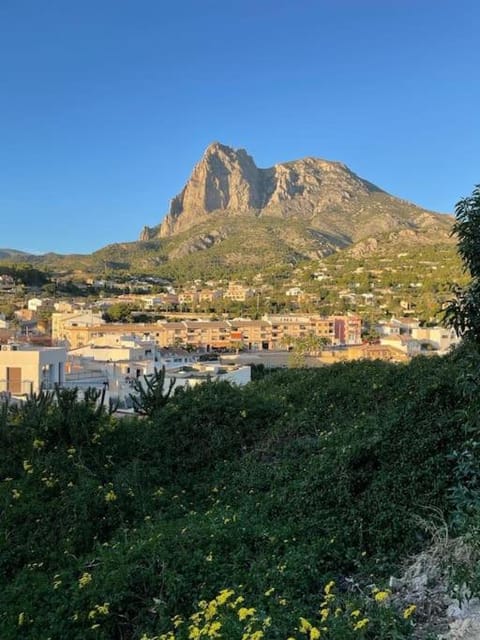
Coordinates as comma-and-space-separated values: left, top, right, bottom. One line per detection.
158, 142, 451, 244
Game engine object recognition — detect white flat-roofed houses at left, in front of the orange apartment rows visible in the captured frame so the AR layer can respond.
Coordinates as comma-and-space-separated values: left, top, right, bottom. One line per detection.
0, 335, 251, 410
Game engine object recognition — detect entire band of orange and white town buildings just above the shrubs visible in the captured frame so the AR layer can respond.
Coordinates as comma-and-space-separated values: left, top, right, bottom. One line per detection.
0, 300, 458, 406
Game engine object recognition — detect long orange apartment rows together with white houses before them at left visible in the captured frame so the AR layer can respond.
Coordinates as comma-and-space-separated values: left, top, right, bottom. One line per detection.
0, 311, 361, 405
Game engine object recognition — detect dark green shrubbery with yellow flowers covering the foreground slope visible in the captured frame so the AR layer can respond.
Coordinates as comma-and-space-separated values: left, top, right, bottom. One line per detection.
0, 349, 480, 640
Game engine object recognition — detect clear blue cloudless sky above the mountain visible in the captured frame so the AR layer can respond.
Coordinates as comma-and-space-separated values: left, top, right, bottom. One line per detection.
0, 0, 480, 252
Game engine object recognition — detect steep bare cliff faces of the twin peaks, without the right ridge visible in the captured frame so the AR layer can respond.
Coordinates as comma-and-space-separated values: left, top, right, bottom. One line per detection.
159, 142, 381, 237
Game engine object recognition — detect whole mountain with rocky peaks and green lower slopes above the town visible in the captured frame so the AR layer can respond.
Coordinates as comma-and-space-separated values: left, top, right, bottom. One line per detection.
0, 143, 453, 279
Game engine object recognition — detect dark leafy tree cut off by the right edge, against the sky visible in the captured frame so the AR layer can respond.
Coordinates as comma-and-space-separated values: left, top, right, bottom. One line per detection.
444, 185, 480, 344
